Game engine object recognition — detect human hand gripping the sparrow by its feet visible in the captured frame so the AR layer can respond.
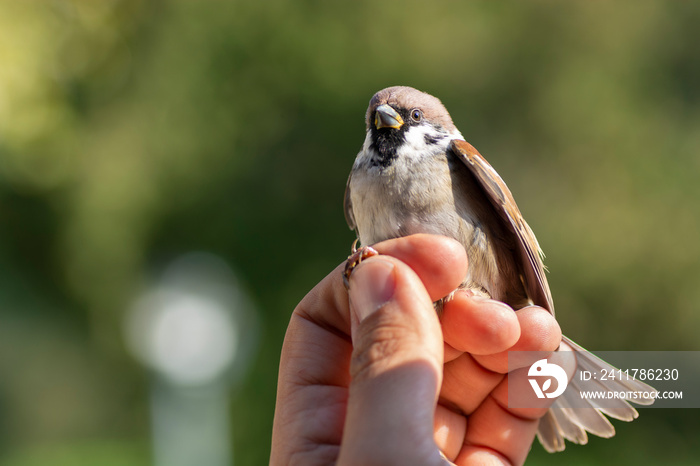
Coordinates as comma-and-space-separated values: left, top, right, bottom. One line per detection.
270, 235, 561, 465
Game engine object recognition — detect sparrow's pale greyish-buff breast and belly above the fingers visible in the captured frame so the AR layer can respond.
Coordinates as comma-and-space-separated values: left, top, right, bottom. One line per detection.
350, 147, 522, 300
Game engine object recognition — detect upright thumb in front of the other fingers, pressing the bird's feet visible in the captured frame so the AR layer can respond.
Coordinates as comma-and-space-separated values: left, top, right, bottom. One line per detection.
339, 256, 444, 464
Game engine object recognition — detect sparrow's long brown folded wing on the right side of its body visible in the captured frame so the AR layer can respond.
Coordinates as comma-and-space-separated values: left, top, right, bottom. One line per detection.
452, 139, 554, 314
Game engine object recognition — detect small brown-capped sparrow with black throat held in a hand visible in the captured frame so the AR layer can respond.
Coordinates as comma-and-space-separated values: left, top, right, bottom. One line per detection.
344, 86, 656, 452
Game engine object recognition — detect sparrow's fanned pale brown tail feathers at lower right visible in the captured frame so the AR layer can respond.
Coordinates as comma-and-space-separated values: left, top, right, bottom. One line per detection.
537, 337, 657, 452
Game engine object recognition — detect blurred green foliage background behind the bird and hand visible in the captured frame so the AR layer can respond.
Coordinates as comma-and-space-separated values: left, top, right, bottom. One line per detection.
0, 0, 700, 466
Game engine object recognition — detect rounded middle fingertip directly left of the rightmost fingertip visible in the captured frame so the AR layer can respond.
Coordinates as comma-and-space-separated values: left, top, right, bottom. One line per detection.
441, 292, 520, 354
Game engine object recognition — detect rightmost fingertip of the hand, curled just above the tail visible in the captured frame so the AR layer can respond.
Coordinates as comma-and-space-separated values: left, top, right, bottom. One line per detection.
475, 306, 561, 373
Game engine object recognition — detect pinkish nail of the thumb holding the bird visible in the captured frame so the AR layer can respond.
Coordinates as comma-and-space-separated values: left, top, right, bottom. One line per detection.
348, 258, 396, 322
